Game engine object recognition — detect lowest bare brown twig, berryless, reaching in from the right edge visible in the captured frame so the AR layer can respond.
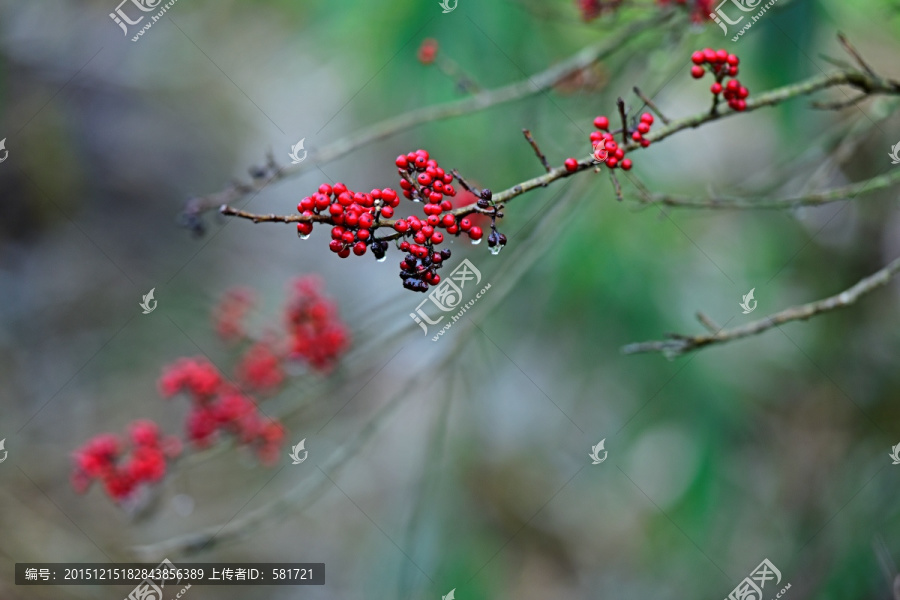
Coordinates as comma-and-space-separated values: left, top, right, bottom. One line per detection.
622, 258, 900, 359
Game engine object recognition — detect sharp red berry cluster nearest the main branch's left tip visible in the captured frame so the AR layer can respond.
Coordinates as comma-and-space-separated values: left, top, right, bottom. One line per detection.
297, 183, 400, 260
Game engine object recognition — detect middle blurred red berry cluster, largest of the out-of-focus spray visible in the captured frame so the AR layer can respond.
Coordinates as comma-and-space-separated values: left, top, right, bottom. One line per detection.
159, 358, 284, 465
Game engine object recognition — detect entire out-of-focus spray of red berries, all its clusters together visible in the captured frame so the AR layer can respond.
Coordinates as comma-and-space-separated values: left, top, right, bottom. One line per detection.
72, 276, 350, 502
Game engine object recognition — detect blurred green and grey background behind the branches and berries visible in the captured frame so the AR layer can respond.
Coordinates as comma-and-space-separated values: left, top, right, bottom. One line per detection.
0, 0, 900, 600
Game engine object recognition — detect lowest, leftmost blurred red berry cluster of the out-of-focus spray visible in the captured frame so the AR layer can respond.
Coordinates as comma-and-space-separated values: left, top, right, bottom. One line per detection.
72, 421, 181, 502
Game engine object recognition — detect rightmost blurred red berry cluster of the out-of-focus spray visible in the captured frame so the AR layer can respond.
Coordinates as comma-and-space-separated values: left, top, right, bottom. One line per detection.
285, 276, 350, 373
